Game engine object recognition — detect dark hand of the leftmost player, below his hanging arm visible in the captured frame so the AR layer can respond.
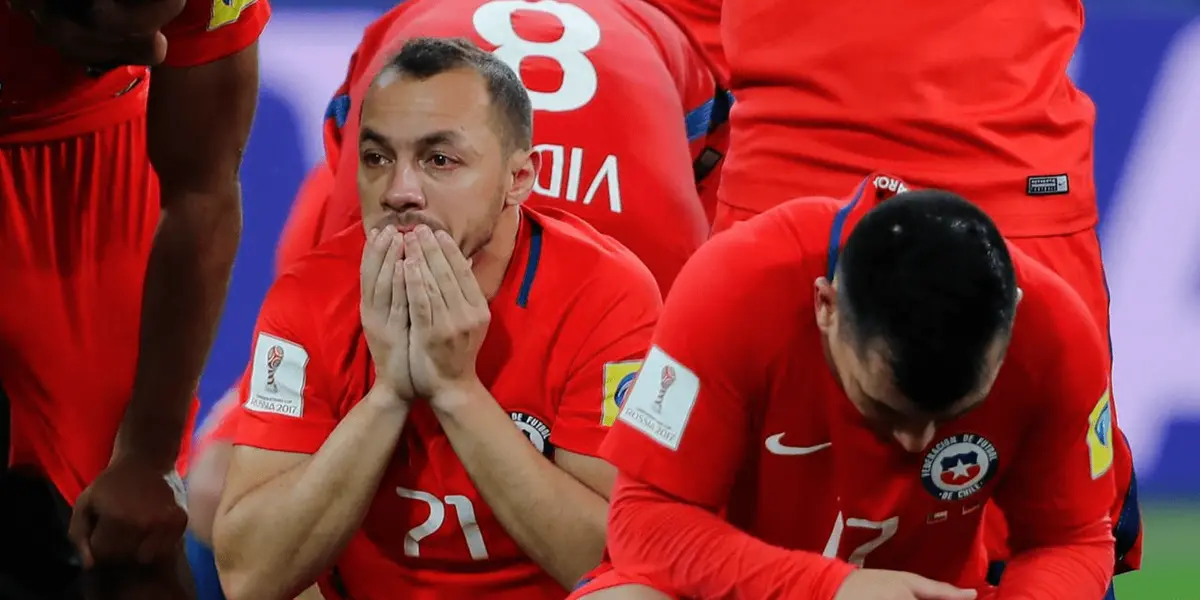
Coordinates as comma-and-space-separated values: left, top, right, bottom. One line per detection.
68, 456, 187, 569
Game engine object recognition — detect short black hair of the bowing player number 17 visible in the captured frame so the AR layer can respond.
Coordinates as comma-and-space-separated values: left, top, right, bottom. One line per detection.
838, 190, 1016, 414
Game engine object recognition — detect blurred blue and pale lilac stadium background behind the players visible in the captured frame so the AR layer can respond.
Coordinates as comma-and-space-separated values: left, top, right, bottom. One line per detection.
200, 0, 1200, 600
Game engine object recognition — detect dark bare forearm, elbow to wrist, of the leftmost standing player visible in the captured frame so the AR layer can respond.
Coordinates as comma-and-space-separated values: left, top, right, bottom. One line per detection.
116, 192, 241, 470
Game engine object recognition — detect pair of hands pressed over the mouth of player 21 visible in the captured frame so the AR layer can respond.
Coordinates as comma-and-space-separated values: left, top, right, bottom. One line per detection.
360, 226, 491, 404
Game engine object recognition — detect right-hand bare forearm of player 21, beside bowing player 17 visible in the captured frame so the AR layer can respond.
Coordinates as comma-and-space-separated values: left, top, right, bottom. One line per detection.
438, 388, 607, 589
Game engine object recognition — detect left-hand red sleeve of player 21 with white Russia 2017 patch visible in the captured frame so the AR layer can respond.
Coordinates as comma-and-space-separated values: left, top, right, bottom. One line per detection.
233, 274, 337, 454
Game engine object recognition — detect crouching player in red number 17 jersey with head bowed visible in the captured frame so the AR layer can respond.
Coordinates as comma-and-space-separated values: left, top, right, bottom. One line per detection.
571, 175, 1116, 600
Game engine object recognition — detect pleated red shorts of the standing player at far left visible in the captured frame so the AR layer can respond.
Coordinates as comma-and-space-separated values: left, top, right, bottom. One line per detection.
0, 119, 194, 503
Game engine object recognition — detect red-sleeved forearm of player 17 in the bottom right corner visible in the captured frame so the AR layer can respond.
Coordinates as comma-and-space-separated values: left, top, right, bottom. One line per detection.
997, 540, 1114, 600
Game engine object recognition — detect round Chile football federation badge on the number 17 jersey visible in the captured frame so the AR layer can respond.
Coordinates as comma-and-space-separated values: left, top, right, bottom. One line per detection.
920, 433, 1000, 502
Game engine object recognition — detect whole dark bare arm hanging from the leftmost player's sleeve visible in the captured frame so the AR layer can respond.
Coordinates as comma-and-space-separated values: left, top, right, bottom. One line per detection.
116, 43, 258, 472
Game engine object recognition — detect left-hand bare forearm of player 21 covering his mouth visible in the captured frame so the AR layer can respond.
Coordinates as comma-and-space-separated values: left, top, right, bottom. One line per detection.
214, 389, 408, 600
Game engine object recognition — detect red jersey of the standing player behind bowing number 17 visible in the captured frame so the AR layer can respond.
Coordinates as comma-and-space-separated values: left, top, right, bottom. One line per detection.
710, 0, 1097, 236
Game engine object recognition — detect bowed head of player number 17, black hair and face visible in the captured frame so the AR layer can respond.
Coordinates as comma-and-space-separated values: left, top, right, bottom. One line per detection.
815, 191, 1021, 452
